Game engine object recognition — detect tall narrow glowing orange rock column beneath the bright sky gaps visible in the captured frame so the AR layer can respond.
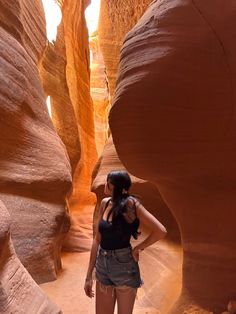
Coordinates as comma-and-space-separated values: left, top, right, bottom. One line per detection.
40, 0, 97, 251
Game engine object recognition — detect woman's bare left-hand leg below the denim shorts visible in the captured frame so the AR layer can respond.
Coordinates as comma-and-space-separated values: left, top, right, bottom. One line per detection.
96, 281, 116, 314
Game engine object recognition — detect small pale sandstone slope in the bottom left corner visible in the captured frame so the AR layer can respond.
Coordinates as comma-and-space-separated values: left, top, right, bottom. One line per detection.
0, 201, 62, 314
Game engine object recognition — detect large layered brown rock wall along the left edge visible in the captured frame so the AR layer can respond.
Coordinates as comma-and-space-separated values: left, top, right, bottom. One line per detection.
0, 0, 71, 282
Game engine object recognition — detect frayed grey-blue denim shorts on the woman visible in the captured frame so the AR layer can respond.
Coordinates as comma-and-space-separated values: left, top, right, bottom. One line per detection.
95, 246, 142, 288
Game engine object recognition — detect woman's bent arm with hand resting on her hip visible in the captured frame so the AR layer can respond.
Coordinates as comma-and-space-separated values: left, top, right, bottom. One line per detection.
133, 201, 167, 261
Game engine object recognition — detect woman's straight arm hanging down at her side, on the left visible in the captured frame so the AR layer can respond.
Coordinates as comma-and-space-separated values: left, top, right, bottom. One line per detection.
84, 199, 107, 298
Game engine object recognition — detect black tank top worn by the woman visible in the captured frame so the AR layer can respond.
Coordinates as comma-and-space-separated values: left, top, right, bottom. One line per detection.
98, 199, 140, 250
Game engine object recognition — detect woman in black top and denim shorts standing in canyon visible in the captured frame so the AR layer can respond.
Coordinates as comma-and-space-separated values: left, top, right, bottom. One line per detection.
84, 171, 166, 314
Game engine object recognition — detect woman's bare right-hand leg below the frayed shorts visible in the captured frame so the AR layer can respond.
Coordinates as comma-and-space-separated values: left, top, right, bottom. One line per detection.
115, 286, 137, 314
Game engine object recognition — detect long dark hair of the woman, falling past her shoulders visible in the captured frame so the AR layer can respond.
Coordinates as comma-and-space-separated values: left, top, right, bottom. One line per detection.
107, 170, 139, 239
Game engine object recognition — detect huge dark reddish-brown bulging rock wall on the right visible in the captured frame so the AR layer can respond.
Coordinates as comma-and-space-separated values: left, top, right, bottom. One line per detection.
110, 0, 236, 314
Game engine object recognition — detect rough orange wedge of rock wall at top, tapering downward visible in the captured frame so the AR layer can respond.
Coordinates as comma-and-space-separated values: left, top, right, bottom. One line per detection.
98, 0, 152, 99
